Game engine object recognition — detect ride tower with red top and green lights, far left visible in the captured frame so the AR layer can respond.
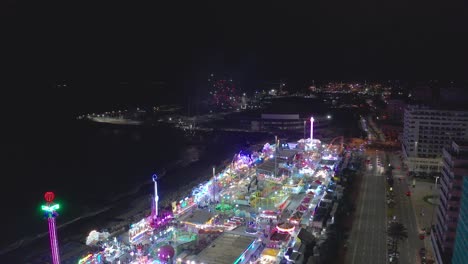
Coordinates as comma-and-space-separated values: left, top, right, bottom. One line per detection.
41, 192, 60, 264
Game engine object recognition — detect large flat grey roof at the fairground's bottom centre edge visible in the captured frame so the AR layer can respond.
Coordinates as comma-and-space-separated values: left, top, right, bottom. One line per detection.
196, 233, 256, 264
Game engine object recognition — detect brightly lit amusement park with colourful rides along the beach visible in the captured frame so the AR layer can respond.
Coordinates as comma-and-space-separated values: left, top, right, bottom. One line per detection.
43, 118, 352, 264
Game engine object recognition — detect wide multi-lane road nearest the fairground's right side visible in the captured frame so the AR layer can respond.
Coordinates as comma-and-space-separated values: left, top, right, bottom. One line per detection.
346, 152, 387, 264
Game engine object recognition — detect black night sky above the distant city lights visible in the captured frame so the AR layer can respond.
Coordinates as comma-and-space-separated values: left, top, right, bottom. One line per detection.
0, 0, 468, 119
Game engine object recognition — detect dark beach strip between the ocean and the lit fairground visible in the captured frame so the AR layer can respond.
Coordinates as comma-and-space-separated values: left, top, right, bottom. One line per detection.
0, 132, 268, 262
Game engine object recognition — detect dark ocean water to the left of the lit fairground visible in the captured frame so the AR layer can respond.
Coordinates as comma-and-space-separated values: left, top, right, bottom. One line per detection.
0, 115, 264, 259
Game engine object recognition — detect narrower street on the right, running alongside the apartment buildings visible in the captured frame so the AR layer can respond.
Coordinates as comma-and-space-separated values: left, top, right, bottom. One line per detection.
389, 153, 424, 264
